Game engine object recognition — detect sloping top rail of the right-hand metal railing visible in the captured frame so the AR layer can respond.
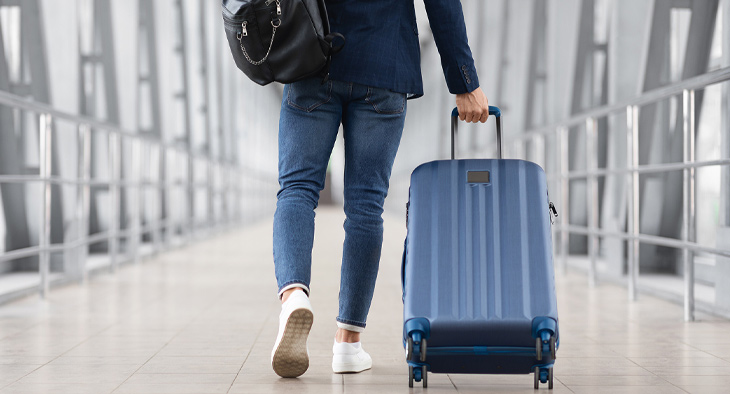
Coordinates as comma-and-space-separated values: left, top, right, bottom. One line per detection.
505, 67, 730, 141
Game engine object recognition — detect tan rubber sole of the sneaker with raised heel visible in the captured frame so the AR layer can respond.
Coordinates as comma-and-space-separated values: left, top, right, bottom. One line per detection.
271, 308, 314, 378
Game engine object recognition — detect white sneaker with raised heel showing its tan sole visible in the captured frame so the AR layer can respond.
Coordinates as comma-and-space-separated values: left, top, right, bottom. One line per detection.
271, 291, 314, 378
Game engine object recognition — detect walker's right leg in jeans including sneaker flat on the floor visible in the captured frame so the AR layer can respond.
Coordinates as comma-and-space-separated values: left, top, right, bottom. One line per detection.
333, 85, 406, 372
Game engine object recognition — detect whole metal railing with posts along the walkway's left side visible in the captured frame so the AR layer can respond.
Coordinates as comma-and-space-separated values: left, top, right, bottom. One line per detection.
0, 91, 276, 297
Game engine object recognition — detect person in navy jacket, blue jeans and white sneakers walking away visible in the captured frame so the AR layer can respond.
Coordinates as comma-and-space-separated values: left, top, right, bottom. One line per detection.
271, 0, 489, 378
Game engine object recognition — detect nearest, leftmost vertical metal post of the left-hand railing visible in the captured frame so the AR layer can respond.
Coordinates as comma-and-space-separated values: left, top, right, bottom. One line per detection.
38, 114, 53, 298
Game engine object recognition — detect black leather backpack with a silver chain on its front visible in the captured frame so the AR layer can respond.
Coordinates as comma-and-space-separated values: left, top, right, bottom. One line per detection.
223, 0, 345, 85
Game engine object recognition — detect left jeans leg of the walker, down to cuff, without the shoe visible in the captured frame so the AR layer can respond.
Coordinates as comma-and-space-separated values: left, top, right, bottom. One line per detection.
274, 78, 342, 298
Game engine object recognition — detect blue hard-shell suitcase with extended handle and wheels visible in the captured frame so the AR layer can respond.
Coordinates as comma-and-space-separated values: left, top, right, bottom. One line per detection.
401, 107, 559, 389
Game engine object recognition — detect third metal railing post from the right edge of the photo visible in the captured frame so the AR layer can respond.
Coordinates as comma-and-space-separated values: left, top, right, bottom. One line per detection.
586, 118, 598, 287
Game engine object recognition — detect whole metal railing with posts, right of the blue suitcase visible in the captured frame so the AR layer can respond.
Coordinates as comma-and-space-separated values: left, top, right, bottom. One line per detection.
500, 67, 730, 321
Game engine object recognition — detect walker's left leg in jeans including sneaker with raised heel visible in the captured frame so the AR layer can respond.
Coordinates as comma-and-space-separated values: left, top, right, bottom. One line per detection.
271, 78, 342, 378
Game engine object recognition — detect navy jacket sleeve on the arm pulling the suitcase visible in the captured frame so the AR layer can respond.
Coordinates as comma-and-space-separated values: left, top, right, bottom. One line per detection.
423, 0, 479, 94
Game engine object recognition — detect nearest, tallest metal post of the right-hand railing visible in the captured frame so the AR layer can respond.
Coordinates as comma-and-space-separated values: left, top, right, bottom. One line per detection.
682, 90, 695, 321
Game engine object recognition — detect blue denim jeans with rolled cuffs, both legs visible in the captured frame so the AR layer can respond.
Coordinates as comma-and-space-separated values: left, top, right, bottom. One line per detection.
274, 78, 406, 328
